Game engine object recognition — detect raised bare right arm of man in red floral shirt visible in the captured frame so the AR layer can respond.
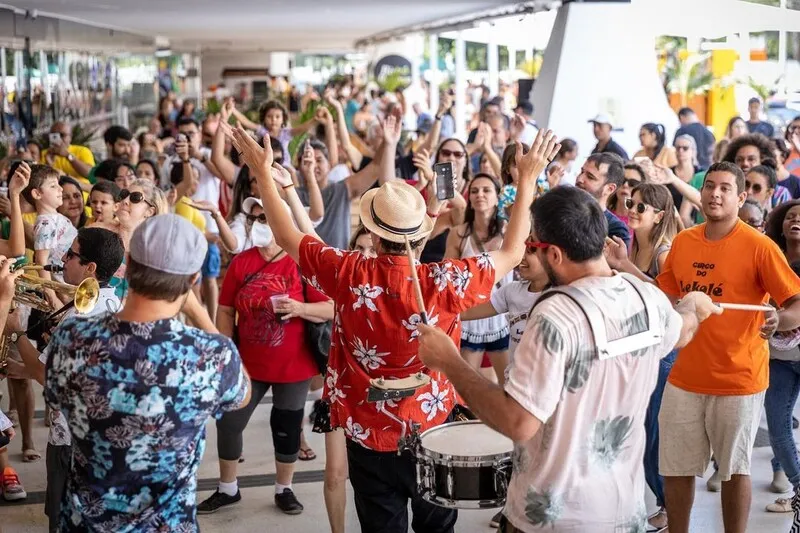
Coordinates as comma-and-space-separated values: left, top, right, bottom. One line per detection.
490, 130, 561, 281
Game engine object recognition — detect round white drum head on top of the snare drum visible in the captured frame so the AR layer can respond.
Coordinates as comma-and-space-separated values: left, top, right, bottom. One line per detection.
420, 420, 514, 463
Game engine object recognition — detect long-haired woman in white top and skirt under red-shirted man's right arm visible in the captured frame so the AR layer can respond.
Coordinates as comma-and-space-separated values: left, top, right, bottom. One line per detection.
445, 174, 512, 385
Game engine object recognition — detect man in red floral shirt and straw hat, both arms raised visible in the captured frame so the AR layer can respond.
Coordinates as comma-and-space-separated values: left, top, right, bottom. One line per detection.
228, 123, 559, 533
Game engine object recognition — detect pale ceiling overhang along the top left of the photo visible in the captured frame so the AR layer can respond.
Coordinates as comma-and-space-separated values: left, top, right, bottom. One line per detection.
6, 0, 514, 51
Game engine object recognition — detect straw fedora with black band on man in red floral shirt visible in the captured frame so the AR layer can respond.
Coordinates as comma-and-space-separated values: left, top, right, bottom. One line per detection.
360, 180, 433, 243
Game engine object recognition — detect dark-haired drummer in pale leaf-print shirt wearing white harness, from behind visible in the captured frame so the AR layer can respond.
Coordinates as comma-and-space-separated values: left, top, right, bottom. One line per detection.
419, 187, 721, 533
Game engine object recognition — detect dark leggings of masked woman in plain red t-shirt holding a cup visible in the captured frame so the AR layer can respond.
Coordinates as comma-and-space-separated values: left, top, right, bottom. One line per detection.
217, 379, 311, 463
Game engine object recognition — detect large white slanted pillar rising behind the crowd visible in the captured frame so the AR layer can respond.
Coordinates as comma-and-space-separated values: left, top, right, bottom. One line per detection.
533, 3, 678, 157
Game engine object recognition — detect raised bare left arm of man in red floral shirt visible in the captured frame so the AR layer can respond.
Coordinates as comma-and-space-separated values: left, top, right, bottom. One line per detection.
233, 127, 305, 263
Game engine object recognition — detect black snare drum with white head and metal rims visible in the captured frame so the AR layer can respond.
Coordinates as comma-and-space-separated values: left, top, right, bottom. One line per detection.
415, 420, 514, 509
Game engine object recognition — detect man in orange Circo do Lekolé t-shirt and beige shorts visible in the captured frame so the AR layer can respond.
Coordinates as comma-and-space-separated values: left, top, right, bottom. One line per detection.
656, 163, 800, 533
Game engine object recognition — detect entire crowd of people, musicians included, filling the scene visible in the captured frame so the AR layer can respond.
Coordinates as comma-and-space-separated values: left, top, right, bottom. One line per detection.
0, 74, 800, 533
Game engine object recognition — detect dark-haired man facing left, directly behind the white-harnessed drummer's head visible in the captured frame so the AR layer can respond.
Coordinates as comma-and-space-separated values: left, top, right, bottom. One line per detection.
575, 152, 631, 248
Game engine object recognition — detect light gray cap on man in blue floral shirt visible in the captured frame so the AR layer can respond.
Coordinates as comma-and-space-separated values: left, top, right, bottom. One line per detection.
128, 215, 208, 276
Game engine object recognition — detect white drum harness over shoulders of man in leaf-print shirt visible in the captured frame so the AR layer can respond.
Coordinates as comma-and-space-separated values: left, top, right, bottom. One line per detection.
529, 273, 663, 361
